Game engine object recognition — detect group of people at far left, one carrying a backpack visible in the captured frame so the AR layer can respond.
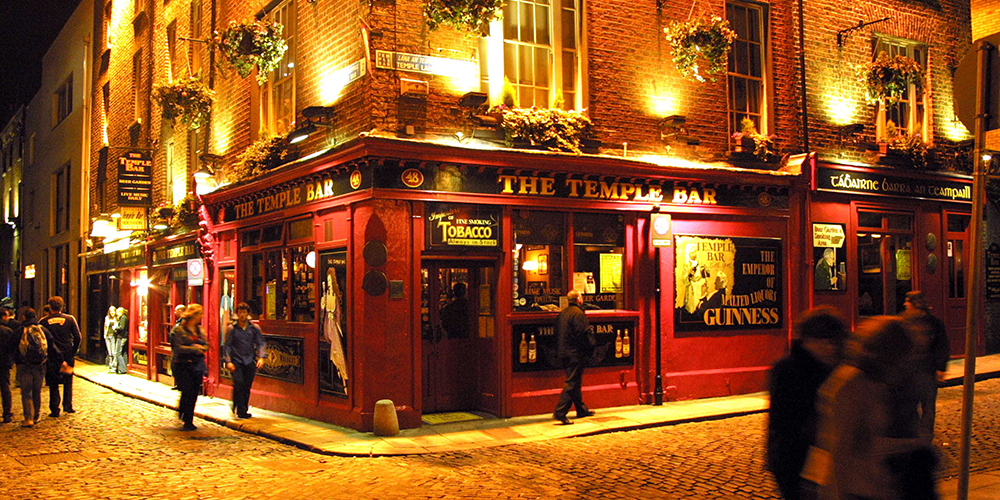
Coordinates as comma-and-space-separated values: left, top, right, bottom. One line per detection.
0, 296, 82, 427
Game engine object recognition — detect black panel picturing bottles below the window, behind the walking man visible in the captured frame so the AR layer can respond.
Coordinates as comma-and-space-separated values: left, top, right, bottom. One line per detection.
512, 318, 635, 372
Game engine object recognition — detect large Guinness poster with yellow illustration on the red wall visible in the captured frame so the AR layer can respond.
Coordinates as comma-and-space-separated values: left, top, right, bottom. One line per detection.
674, 236, 784, 332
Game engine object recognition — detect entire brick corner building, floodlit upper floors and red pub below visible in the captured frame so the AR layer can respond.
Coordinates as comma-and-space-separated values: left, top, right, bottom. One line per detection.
87, 0, 969, 429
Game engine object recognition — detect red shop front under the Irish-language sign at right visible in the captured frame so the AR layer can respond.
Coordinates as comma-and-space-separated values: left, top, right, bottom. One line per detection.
807, 162, 972, 355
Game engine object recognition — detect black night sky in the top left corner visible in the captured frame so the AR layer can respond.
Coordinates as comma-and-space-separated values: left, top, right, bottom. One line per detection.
0, 0, 80, 128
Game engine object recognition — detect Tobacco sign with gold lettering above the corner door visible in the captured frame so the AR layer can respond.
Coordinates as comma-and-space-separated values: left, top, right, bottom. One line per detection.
425, 203, 503, 250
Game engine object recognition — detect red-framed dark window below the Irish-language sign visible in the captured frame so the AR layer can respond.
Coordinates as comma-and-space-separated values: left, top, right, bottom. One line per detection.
857, 210, 913, 316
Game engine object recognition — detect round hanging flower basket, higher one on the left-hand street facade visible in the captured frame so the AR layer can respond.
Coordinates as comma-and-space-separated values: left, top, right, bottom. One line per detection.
215, 19, 288, 85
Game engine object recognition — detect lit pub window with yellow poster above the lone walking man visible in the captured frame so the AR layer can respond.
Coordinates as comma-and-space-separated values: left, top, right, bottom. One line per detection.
571, 213, 625, 309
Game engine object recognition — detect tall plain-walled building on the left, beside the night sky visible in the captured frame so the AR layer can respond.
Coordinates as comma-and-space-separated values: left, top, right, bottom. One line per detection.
22, 0, 94, 359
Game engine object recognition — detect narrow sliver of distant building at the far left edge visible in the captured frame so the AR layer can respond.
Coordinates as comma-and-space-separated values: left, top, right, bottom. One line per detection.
0, 106, 27, 306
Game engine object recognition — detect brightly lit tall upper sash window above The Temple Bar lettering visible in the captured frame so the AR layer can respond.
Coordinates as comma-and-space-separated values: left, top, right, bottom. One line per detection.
490, 0, 584, 109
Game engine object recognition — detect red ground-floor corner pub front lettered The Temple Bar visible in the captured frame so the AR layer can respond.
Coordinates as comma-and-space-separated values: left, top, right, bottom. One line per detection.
203, 138, 808, 429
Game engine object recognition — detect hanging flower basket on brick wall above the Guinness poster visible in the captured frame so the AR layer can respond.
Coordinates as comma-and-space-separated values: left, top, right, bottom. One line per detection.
663, 17, 736, 82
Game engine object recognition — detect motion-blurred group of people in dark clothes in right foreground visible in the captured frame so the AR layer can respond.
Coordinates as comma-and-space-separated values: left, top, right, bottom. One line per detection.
767, 291, 949, 500
